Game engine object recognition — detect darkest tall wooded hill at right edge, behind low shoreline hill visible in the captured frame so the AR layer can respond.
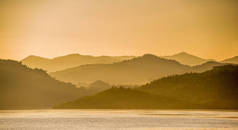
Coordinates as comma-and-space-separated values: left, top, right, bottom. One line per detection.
139, 65, 238, 108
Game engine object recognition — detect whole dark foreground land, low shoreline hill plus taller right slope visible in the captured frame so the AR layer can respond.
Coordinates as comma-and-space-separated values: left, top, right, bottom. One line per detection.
55, 65, 238, 109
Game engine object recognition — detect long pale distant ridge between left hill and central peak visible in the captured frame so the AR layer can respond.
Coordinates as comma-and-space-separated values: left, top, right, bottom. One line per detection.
22, 54, 133, 72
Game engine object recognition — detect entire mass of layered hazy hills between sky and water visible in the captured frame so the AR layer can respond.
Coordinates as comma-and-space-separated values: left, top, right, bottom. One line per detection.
0, 53, 238, 109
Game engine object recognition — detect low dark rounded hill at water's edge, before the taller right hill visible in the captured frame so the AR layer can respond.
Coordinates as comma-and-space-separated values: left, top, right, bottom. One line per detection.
54, 88, 192, 109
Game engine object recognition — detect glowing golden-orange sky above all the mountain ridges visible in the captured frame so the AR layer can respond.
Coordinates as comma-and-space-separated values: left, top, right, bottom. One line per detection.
0, 0, 238, 60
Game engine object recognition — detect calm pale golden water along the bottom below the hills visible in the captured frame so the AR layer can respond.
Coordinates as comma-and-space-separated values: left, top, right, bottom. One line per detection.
0, 110, 238, 130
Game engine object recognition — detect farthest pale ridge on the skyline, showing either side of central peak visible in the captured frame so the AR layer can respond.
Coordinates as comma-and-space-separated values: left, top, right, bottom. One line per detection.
21, 52, 238, 72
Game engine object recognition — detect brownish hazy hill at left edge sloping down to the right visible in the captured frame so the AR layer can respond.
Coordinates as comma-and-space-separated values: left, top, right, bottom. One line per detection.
0, 60, 85, 109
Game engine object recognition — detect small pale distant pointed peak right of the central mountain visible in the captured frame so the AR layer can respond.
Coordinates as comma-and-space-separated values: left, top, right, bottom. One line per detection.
164, 52, 208, 66
